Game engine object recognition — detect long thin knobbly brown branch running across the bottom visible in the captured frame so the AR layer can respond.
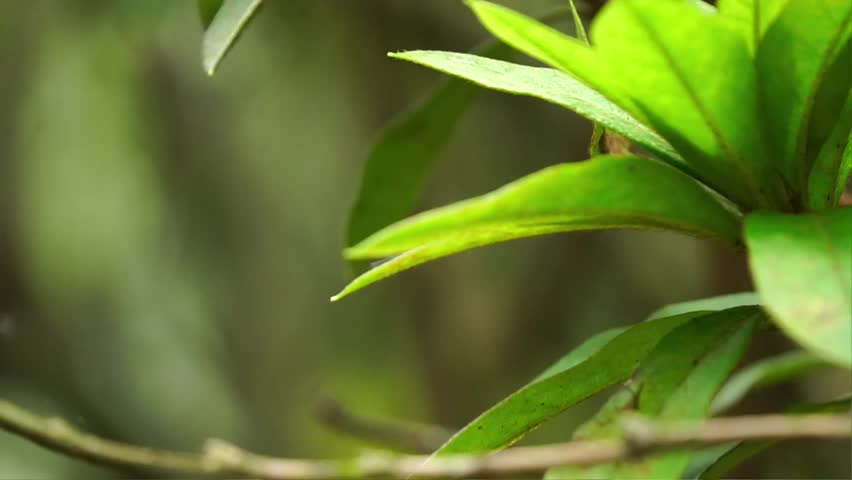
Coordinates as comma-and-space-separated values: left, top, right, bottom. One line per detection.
0, 400, 852, 480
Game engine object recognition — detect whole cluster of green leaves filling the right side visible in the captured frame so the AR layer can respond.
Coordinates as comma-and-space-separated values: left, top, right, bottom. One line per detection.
201, 0, 852, 479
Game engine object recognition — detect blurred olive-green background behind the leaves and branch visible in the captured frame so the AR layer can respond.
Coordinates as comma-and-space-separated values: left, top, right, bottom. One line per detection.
0, 0, 850, 478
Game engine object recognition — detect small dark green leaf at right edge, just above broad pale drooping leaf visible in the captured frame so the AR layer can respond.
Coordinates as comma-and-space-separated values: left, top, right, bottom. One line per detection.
808, 93, 852, 210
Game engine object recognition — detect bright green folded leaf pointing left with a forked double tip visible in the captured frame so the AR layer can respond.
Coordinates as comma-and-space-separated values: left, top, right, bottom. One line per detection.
332, 156, 740, 300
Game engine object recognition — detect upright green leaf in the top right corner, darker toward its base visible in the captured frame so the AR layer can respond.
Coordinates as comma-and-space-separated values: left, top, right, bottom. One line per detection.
756, 0, 852, 187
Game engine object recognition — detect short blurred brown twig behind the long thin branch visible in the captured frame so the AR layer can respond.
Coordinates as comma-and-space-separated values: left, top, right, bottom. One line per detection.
314, 399, 452, 453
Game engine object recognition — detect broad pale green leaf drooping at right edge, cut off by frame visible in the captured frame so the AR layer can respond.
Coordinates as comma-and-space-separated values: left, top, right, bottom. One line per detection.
745, 208, 852, 367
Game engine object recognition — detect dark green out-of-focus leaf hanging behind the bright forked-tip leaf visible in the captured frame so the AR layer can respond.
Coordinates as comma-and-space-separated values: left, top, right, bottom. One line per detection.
346, 8, 580, 245
